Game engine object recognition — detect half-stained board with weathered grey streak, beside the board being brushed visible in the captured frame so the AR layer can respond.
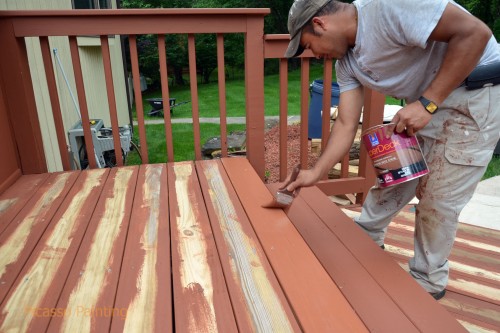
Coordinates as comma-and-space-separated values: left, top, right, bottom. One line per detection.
196, 161, 300, 332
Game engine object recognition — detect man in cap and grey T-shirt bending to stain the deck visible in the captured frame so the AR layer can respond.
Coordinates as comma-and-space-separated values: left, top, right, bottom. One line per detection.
285, 0, 500, 299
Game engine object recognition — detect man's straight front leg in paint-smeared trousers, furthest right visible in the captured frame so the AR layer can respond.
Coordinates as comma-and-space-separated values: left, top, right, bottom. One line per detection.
410, 144, 486, 293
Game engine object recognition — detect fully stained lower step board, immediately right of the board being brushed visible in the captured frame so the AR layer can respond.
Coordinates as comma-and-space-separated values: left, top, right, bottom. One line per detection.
268, 180, 418, 332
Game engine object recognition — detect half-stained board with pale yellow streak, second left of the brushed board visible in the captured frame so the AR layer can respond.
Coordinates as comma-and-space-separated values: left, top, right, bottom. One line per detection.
168, 162, 238, 332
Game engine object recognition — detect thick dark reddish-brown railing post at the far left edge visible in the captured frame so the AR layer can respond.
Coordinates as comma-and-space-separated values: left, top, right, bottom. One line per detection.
0, 19, 47, 174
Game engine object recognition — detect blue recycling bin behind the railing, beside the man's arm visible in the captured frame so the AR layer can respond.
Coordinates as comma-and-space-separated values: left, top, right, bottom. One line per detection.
308, 80, 340, 139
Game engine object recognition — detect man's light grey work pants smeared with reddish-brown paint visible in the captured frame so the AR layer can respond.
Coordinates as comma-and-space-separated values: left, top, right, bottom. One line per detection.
355, 85, 500, 292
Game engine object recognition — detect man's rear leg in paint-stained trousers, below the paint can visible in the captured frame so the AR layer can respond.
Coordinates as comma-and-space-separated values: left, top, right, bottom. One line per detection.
354, 179, 418, 246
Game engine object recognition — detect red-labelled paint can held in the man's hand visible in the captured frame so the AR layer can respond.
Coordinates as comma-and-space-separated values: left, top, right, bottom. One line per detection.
361, 123, 429, 187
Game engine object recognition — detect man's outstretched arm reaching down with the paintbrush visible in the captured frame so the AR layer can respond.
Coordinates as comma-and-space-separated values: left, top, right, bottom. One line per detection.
287, 87, 363, 191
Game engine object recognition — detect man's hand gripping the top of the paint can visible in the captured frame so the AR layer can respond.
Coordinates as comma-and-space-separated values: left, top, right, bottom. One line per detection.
386, 101, 432, 137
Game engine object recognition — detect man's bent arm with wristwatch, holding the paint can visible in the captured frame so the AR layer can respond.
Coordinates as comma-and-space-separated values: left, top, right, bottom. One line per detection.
392, 3, 491, 135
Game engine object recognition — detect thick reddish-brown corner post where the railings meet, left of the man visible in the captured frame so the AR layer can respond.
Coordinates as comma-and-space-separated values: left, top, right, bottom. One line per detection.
245, 16, 265, 179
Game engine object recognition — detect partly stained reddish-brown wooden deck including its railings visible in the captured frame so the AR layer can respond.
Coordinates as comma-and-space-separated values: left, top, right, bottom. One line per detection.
0, 8, 500, 333
